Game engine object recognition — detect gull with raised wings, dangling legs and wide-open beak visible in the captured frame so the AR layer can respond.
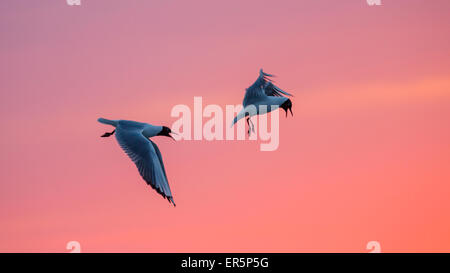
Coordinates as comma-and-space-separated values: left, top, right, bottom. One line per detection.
231, 68, 294, 136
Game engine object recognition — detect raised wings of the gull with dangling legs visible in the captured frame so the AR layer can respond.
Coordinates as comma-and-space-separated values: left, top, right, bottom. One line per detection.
242, 69, 292, 107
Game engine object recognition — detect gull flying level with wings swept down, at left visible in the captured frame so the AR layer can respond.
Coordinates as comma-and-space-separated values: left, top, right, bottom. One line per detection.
98, 118, 176, 206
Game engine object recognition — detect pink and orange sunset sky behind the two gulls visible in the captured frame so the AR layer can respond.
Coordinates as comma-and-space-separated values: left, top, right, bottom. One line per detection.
0, 0, 450, 252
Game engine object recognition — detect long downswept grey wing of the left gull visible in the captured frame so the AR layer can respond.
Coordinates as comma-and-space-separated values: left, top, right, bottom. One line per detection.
116, 127, 175, 206
